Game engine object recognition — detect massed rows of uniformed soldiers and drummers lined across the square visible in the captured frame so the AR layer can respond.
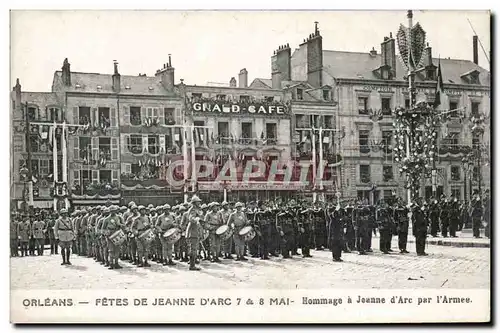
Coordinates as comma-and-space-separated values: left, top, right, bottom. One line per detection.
10, 195, 490, 270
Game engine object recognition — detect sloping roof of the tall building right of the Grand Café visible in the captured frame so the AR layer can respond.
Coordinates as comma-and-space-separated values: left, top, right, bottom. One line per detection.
323, 50, 490, 86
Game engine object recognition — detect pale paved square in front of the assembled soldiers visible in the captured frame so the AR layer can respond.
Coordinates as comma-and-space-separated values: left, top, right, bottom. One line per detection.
11, 237, 490, 289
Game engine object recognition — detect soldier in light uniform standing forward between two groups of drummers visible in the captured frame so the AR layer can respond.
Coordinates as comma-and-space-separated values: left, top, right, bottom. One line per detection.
185, 195, 204, 271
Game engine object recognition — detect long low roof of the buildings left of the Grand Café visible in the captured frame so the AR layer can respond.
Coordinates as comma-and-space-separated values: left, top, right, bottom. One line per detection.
54, 71, 180, 96
